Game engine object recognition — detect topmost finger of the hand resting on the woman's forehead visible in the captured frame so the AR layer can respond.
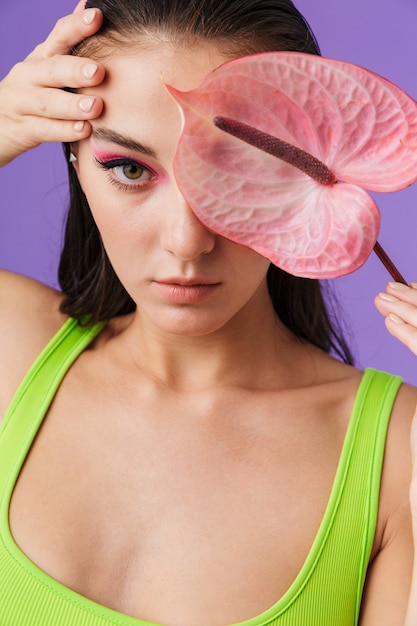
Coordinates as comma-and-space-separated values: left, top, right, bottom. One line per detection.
28, 9, 103, 58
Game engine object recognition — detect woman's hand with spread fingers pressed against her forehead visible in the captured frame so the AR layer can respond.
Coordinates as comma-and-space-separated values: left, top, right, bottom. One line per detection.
0, 6, 105, 166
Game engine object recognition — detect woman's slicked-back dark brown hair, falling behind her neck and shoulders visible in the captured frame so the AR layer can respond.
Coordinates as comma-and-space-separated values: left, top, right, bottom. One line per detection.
58, 0, 353, 363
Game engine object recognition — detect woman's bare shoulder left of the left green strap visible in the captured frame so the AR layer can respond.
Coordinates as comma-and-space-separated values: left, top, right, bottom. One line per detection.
0, 270, 66, 421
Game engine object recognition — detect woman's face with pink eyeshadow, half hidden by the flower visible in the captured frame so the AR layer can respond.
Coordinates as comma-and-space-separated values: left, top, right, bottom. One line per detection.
75, 43, 270, 335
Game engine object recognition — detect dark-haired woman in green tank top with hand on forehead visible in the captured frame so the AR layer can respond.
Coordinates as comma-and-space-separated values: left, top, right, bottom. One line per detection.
0, 0, 417, 626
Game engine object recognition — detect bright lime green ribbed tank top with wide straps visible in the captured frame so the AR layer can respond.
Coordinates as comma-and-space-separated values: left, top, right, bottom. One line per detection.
0, 320, 401, 626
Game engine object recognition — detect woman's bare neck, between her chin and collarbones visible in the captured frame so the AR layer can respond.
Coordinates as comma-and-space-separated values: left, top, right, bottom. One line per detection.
112, 296, 299, 391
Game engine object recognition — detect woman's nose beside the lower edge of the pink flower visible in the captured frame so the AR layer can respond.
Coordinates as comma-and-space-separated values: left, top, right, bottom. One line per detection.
160, 189, 216, 261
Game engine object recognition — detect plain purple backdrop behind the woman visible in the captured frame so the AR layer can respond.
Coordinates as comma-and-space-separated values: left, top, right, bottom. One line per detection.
0, 0, 417, 384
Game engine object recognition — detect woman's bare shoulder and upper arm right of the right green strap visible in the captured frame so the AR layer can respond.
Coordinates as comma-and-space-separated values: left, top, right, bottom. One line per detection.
360, 376, 417, 626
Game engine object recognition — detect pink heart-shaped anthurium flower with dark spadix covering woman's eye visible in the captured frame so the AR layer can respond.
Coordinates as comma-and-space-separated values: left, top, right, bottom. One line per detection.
167, 52, 417, 278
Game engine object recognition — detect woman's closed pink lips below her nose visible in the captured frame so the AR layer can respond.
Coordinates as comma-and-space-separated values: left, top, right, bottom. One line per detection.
153, 278, 221, 304
